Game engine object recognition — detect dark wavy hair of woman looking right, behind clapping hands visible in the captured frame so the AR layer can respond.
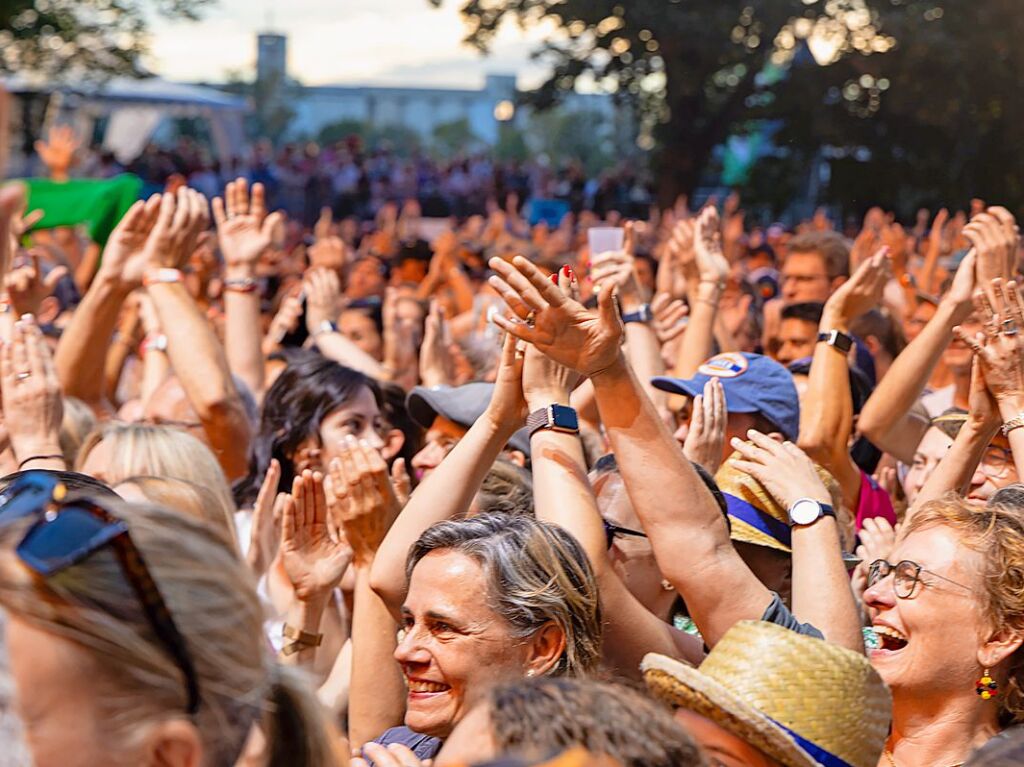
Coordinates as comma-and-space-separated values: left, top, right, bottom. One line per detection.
233, 353, 383, 508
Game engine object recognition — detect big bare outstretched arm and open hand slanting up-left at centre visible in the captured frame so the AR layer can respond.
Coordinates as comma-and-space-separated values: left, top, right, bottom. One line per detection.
490, 257, 772, 646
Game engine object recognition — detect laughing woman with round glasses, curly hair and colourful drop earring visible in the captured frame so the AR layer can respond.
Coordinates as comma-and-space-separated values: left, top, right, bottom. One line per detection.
864, 497, 1024, 767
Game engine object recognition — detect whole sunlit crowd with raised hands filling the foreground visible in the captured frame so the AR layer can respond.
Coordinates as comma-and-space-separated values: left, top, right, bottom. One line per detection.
0, 125, 1024, 767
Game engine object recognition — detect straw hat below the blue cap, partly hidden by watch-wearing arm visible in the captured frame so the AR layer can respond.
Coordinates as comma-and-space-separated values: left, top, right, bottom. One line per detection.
715, 453, 860, 564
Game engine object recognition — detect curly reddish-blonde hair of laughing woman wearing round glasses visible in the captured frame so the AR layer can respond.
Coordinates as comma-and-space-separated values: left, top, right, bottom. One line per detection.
902, 494, 1024, 723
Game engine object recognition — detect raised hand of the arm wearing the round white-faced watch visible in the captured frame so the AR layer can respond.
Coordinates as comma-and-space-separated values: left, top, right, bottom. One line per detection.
730, 429, 831, 508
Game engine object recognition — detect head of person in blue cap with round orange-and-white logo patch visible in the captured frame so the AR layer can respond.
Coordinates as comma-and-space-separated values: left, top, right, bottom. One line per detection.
651, 351, 800, 461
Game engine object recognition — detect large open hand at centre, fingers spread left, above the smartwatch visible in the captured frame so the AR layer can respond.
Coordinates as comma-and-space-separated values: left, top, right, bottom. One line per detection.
488, 256, 623, 376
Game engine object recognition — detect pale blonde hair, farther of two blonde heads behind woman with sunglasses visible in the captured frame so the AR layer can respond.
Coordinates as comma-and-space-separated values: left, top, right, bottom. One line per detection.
75, 421, 236, 518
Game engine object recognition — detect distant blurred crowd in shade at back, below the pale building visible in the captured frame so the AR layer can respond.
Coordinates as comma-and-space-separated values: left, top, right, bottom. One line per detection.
68, 129, 651, 226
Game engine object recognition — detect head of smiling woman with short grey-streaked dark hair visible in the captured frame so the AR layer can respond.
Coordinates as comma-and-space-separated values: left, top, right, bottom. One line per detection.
370, 513, 601, 757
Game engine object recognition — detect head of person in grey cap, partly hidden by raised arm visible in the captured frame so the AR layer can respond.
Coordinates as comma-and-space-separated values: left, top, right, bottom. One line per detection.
407, 382, 529, 481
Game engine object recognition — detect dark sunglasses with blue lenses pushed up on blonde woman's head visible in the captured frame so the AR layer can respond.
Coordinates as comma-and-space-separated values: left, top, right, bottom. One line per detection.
0, 471, 200, 715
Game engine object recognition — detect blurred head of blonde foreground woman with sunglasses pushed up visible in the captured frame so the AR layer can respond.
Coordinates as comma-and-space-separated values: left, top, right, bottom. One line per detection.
0, 471, 340, 767
